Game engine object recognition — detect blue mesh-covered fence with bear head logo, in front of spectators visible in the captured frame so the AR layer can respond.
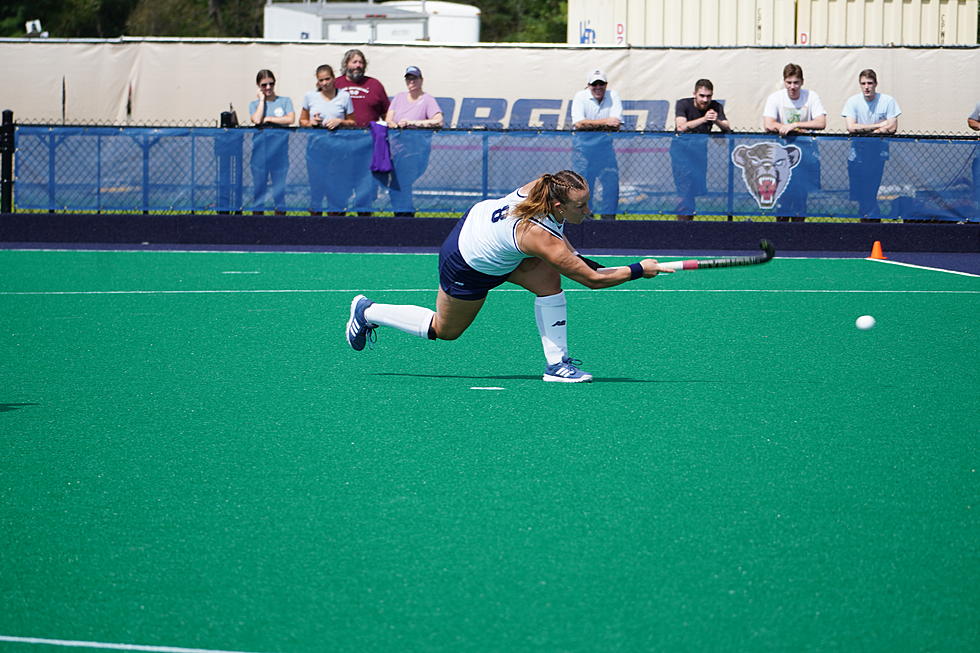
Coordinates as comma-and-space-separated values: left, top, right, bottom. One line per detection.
14, 125, 980, 222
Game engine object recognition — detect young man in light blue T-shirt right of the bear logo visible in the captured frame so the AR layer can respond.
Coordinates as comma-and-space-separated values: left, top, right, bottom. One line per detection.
841, 68, 902, 222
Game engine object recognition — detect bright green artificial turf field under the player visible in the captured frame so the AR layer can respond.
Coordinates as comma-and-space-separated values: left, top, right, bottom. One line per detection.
0, 251, 980, 653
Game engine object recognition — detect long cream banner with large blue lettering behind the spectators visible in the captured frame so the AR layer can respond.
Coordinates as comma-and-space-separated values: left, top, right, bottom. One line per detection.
0, 39, 980, 134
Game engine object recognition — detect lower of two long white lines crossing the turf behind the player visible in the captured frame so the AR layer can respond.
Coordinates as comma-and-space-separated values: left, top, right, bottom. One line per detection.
0, 288, 980, 297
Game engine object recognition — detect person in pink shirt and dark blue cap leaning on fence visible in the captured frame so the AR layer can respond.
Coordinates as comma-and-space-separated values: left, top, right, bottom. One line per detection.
385, 66, 443, 218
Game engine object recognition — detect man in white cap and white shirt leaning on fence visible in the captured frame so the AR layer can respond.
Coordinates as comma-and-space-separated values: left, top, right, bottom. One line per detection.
572, 70, 623, 220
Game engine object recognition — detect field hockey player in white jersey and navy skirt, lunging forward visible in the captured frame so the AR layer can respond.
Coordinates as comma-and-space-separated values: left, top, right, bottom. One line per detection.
346, 170, 674, 383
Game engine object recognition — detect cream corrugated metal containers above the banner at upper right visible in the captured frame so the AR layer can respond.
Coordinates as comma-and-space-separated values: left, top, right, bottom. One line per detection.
568, 0, 978, 47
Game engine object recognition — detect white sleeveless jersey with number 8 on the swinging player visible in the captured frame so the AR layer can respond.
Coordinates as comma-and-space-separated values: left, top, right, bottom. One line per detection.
459, 189, 565, 276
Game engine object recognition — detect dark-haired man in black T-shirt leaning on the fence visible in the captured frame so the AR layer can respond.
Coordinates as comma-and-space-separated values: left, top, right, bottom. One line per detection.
670, 79, 732, 220
